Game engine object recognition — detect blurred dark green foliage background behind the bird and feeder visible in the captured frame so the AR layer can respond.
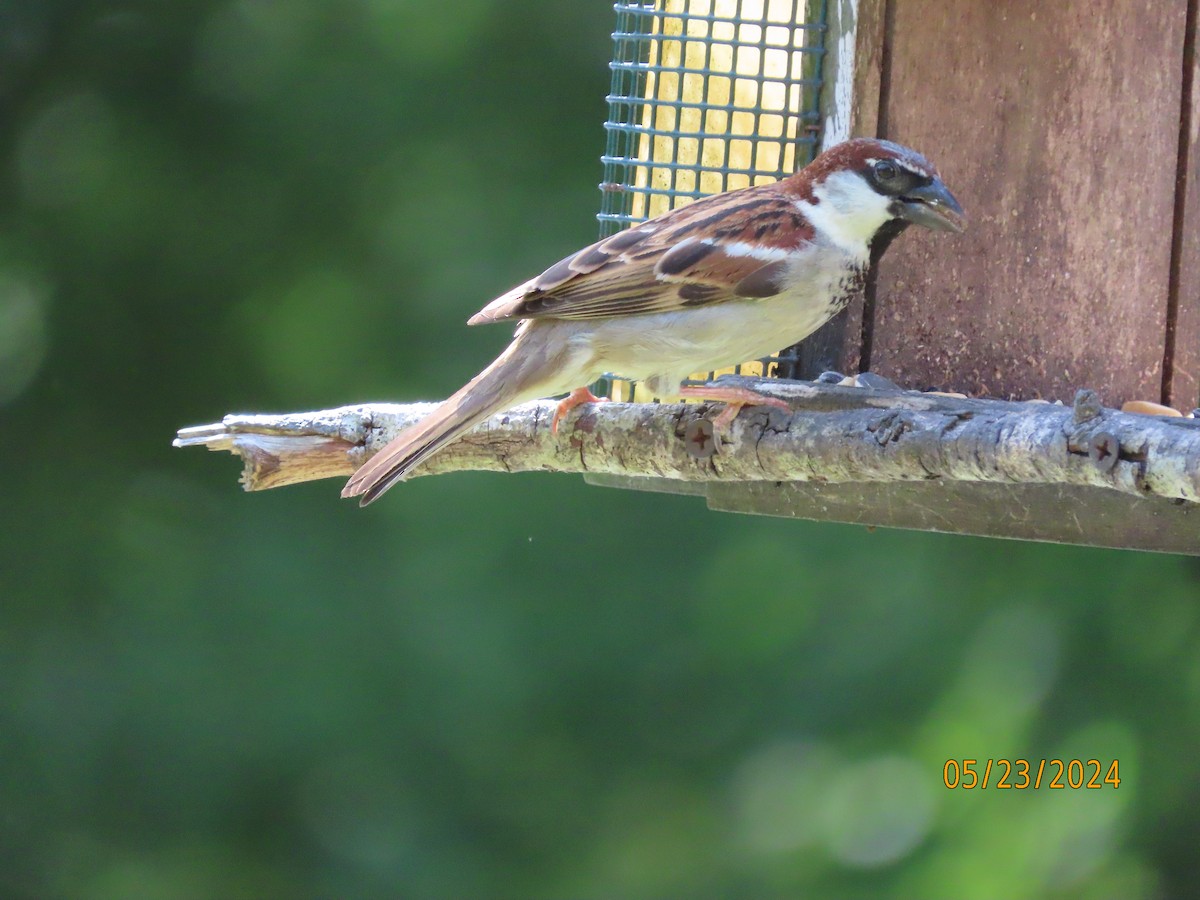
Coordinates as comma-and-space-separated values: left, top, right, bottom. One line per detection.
0, 0, 1200, 900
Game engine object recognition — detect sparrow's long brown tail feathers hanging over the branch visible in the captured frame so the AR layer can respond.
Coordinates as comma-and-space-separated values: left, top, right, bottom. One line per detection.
342, 342, 557, 506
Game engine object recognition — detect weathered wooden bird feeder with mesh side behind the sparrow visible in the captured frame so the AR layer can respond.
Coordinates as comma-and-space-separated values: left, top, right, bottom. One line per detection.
576, 0, 1200, 552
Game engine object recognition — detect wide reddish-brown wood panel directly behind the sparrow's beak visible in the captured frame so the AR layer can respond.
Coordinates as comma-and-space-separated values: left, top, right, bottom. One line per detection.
870, 0, 1190, 404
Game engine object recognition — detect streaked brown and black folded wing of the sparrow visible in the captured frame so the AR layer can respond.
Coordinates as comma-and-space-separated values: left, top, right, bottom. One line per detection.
470, 185, 811, 324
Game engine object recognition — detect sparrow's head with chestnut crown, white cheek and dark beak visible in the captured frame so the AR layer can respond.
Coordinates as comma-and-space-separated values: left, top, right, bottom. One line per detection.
790, 138, 966, 255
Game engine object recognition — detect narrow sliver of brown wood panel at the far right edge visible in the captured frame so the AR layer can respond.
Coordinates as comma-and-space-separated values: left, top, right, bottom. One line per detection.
1164, 0, 1200, 410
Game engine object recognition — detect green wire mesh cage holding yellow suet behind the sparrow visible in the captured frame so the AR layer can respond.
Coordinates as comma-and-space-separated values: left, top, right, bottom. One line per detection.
598, 0, 826, 400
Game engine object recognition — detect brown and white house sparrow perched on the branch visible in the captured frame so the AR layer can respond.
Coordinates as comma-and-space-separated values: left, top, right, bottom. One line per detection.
342, 138, 965, 506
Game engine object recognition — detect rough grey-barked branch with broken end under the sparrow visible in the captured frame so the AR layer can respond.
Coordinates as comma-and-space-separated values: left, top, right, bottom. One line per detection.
174, 378, 1200, 502
